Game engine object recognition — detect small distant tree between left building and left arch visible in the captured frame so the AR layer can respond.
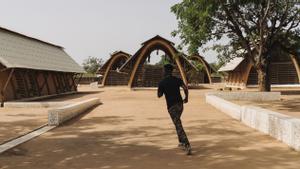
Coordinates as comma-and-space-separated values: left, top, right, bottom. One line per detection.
82, 56, 103, 74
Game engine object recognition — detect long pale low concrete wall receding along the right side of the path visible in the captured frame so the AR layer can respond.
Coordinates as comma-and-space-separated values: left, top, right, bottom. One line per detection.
206, 94, 300, 151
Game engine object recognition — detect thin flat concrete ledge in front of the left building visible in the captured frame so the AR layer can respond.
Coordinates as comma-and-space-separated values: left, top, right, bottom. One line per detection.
4, 102, 71, 108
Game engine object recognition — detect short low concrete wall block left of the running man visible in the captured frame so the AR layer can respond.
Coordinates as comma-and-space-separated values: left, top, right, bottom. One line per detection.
48, 98, 100, 126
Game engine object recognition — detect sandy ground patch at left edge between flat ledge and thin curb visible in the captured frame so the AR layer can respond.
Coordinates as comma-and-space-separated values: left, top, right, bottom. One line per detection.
0, 108, 47, 143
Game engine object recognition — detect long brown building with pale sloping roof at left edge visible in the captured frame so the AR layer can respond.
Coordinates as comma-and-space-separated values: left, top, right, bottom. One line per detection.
0, 27, 84, 105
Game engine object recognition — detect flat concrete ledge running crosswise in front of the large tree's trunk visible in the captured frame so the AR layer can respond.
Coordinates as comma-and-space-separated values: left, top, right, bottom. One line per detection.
206, 92, 281, 101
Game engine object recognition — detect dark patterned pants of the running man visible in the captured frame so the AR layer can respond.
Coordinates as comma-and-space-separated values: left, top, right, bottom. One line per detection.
168, 103, 190, 147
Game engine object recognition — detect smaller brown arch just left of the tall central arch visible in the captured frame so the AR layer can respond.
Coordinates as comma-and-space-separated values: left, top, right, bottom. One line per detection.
102, 52, 130, 86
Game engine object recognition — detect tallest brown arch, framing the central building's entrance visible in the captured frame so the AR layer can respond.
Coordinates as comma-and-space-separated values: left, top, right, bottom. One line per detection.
128, 36, 188, 87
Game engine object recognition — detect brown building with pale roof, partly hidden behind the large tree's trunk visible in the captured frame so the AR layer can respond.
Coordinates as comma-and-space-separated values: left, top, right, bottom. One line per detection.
219, 51, 300, 88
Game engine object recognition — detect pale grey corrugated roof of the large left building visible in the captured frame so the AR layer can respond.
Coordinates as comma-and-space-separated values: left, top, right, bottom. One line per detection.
0, 27, 84, 73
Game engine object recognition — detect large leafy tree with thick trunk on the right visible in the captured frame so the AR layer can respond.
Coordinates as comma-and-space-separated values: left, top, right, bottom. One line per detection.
171, 0, 300, 91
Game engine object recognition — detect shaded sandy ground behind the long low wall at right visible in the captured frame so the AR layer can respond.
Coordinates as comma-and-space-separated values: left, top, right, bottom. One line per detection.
234, 89, 300, 118
